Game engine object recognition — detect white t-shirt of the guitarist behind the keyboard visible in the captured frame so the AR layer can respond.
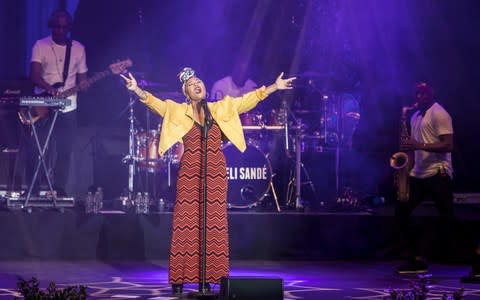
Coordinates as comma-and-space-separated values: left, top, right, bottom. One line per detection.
31, 36, 88, 112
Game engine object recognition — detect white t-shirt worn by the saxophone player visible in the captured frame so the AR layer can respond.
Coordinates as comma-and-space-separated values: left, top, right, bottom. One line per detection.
410, 102, 453, 178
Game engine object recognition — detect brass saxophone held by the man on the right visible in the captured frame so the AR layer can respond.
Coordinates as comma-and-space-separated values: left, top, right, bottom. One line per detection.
390, 103, 417, 202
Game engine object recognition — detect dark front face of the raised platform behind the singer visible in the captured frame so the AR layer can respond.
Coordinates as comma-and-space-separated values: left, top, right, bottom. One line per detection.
0, 210, 474, 262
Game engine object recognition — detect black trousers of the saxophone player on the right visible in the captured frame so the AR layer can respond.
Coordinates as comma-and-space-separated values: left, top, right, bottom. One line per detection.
395, 173, 459, 258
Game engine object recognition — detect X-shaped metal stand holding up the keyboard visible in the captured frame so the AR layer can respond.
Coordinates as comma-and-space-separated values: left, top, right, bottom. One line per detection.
23, 107, 59, 212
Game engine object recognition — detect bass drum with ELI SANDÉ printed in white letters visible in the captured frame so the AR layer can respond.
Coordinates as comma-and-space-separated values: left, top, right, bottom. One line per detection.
223, 143, 272, 208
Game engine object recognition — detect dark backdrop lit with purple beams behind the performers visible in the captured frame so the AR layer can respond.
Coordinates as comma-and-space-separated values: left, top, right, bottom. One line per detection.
0, 0, 480, 201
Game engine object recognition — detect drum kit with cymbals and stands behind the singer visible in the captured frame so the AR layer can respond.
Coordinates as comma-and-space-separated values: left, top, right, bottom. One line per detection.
120, 75, 360, 211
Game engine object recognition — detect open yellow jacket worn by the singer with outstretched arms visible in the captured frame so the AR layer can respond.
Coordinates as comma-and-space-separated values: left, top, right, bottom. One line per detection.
143, 86, 267, 155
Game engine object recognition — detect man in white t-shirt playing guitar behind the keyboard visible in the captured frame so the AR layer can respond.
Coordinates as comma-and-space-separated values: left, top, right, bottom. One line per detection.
27, 10, 88, 196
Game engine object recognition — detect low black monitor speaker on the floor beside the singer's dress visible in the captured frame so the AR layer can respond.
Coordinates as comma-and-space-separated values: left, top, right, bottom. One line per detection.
220, 276, 283, 300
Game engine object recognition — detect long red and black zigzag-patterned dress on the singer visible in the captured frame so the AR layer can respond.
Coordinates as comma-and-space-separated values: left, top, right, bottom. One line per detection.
169, 122, 229, 284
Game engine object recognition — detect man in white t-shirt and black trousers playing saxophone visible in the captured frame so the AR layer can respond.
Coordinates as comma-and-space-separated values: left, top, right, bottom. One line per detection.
395, 82, 457, 274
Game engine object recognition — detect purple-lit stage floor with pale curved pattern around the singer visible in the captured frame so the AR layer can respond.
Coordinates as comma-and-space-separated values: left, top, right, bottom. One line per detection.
0, 261, 480, 300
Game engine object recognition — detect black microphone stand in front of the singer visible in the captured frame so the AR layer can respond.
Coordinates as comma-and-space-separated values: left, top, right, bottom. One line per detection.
188, 99, 216, 299
